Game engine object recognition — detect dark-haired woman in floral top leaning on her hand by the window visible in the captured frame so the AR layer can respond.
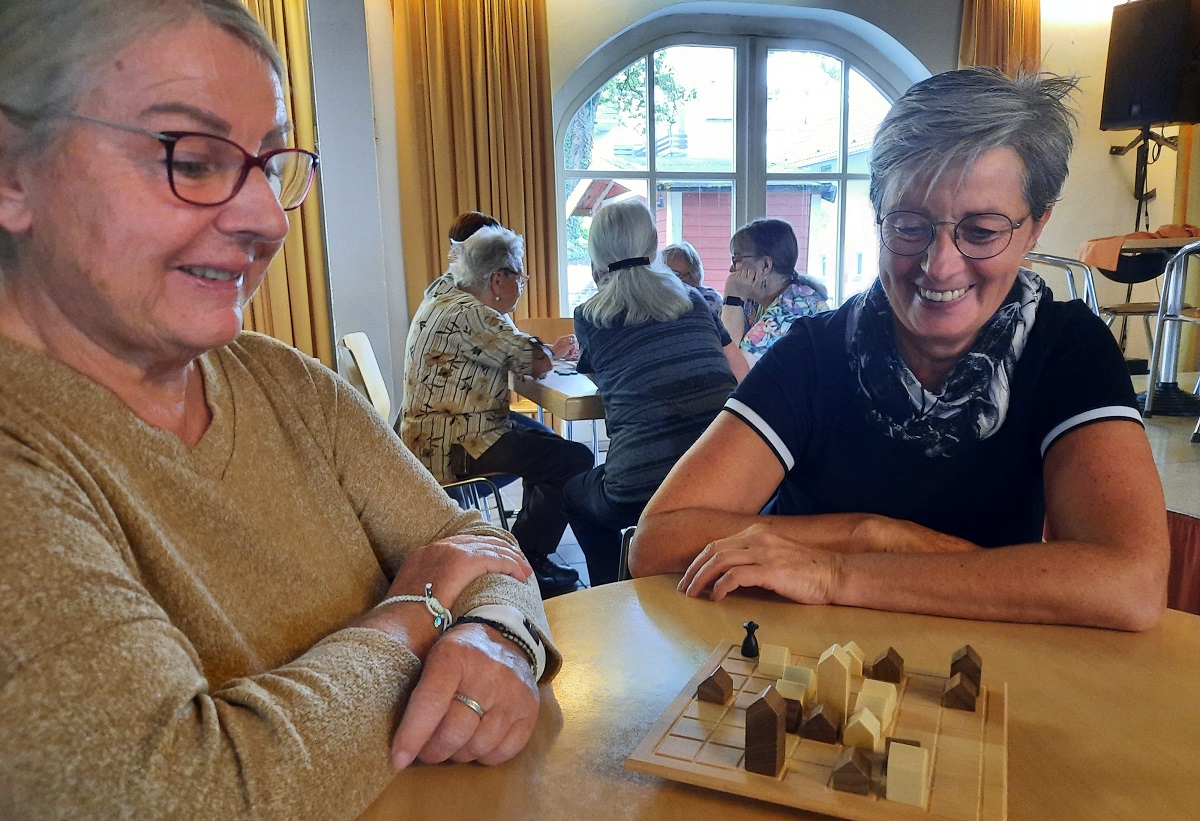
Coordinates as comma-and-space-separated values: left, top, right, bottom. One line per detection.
720, 218, 829, 382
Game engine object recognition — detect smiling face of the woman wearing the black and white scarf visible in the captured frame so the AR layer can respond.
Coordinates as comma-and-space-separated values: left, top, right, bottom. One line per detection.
880, 148, 1050, 386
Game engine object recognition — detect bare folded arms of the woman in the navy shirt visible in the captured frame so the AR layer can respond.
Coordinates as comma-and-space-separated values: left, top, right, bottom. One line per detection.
630, 414, 1169, 630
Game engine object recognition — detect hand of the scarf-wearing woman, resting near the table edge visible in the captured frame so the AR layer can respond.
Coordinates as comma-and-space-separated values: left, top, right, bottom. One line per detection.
679, 525, 841, 604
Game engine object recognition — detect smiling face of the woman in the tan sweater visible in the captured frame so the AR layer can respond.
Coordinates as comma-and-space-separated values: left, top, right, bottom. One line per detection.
0, 18, 288, 368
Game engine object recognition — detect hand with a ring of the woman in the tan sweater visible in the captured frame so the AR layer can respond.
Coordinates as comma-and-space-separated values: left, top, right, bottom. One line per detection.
391, 624, 540, 769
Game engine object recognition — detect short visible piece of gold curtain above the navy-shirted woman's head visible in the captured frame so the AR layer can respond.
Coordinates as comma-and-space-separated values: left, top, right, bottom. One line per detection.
959, 0, 1042, 77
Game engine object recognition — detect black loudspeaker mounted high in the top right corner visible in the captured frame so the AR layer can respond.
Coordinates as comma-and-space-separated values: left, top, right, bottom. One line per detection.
1100, 0, 1200, 131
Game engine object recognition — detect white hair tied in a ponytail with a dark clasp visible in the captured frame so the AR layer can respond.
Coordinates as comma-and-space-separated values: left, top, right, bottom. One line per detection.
580, 199, 692, 328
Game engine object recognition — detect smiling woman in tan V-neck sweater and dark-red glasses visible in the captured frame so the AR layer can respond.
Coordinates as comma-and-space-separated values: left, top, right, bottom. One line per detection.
0, 0, 560, 819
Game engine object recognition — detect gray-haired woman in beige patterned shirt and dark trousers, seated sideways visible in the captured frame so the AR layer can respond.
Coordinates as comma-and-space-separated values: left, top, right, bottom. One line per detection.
398, 226, 593, 597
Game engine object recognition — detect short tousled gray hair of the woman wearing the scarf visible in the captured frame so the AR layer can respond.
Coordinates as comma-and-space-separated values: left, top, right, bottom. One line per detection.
870, 66, 1079, 220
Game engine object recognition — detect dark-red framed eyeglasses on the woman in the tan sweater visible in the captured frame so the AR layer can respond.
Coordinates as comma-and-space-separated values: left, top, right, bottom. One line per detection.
71, 114, 320, 211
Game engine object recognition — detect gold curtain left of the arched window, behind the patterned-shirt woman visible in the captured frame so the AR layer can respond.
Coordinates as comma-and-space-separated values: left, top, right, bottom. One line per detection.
392, 0, 558, 317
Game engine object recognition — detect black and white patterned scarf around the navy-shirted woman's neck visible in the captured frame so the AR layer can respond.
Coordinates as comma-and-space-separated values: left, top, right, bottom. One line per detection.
846, 268, 1049, 456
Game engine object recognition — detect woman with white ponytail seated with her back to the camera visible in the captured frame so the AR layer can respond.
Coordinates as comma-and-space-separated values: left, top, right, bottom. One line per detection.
566, 199, 740, 587
